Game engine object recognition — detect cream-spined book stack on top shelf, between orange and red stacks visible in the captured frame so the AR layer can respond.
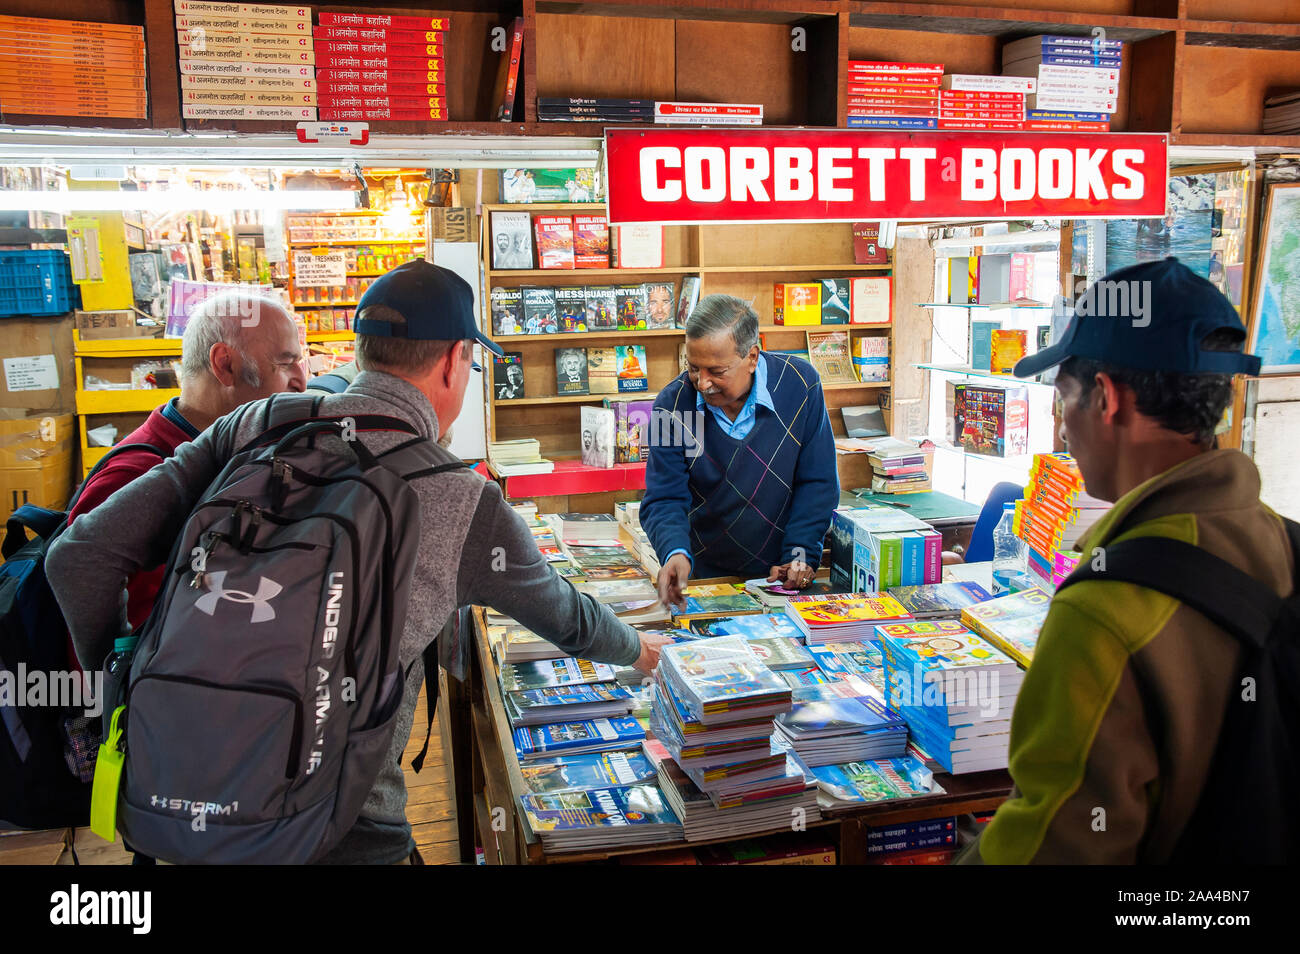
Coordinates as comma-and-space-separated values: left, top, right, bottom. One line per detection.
174, 0, 317, 122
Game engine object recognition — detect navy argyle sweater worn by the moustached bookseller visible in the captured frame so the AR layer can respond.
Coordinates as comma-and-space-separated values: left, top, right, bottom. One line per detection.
641, 351, 840, 578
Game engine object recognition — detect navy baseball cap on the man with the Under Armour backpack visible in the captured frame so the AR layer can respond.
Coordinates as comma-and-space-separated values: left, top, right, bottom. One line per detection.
352, 259, 506, 370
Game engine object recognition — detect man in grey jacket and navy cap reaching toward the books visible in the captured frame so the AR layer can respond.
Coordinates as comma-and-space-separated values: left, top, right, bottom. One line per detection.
48, 261, 664, 864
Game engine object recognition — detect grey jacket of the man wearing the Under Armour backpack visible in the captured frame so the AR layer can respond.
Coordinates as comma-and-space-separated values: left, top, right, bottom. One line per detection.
46, 372, 640, 864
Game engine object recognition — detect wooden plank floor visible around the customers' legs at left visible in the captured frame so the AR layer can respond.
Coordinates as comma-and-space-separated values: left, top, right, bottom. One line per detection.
0, 689, 460, 864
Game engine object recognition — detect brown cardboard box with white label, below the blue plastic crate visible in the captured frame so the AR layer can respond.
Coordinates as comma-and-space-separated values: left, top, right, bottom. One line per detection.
0, 315, 77, 413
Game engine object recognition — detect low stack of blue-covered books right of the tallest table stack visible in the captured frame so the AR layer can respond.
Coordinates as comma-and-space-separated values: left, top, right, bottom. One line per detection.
776, 695, 907, 767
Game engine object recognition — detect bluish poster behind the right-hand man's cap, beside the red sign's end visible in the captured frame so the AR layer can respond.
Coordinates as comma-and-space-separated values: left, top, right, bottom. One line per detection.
1106, 174, 1214, 278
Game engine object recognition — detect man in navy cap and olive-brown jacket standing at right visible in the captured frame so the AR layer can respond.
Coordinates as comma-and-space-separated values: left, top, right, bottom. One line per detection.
961, 259, 1295, 864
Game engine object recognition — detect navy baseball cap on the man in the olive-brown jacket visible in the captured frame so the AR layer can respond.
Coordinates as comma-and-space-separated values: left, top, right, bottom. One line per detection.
1015, 256, 1260, 378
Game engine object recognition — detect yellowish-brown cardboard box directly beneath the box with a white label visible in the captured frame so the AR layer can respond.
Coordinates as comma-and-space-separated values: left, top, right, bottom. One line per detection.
0, 411, 77, 516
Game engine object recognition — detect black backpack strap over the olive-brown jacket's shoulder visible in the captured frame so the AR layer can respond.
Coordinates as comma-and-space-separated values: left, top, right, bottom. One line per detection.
1057, 530, 1300, 649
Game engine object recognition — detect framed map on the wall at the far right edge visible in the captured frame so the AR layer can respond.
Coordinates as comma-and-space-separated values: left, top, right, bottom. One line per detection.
1249, 182, 1300, 374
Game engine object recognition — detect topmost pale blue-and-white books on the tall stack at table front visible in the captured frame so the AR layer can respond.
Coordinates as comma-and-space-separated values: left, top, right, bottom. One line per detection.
659, 636, 790, 725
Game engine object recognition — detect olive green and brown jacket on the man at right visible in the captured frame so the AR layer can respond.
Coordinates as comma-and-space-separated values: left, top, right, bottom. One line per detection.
958, 450, 1294, 864
